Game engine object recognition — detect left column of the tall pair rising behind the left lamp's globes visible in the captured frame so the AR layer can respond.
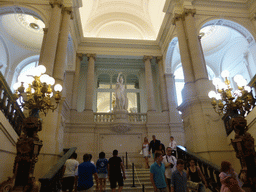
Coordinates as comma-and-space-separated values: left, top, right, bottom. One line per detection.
39, 0, 63, 76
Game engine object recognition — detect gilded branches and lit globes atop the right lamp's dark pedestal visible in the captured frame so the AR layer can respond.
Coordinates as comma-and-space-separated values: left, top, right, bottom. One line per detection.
208, 71, 255, 117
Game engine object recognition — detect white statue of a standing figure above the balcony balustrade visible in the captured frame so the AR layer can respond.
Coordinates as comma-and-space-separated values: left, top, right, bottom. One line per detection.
115, 73, 127, 109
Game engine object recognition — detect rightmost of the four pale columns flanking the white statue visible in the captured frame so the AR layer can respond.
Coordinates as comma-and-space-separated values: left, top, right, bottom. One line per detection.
156, 56, 168, 111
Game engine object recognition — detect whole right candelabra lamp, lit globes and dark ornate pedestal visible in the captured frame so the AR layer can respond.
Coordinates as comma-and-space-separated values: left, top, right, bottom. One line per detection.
208, 71, 256, 191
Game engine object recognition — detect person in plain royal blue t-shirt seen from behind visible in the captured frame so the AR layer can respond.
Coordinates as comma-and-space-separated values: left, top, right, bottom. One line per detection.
77, 154, 99, 192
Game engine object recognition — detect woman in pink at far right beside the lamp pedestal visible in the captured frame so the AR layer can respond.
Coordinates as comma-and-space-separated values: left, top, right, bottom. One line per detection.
219, 161, 244, 192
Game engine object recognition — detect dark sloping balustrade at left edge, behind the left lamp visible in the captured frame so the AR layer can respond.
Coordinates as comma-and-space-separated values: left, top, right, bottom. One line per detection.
0, 72, 25, 135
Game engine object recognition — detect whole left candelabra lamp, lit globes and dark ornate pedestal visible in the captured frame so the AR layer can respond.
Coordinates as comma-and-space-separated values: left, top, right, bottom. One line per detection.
0, 65, 62, 192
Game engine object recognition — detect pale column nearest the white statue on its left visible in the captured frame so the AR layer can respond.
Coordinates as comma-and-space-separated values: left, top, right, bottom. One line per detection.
85, 54, 96, 111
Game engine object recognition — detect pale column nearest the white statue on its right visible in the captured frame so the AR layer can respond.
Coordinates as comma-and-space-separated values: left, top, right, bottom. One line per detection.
143, 56, 156, 111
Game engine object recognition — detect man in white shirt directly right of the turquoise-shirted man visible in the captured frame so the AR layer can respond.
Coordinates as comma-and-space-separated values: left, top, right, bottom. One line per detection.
163, 147, 177, 191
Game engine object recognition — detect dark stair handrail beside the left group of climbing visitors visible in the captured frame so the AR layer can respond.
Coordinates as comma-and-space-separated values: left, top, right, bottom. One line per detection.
39, 147, 77, 192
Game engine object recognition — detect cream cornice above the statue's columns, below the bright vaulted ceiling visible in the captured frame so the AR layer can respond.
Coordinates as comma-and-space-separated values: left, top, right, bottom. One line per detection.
77, 38, 162, 56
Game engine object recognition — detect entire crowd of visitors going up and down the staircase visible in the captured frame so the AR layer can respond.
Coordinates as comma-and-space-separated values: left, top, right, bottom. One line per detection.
62, 135, 244, 192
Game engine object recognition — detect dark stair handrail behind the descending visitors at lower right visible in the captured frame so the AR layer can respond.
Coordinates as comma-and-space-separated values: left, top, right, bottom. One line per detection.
177, 145, 221, 192
